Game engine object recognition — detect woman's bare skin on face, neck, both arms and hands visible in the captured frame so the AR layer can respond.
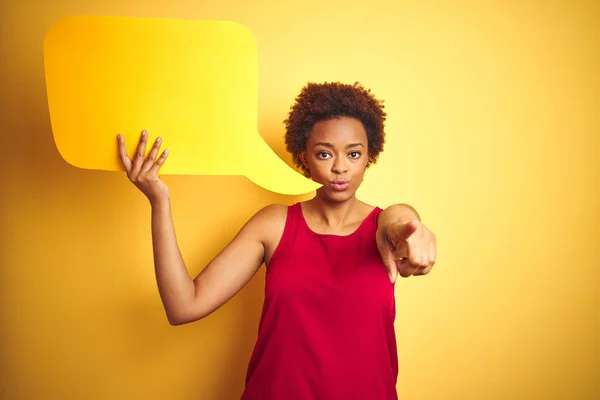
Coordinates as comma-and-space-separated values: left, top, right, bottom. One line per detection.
117, 117, 435, 325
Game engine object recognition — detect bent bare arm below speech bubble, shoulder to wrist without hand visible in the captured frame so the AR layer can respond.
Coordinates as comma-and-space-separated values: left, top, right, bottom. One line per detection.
152, 201, 283, 325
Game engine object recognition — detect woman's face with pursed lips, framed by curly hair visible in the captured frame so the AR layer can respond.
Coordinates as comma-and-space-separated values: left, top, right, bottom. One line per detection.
300, 117, 369, 201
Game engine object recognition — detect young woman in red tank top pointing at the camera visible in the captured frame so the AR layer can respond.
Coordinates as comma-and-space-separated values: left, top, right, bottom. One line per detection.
118, 79, 436, 400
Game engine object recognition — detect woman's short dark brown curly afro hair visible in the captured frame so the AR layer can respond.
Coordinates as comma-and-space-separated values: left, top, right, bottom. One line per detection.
284, 82, 386, 177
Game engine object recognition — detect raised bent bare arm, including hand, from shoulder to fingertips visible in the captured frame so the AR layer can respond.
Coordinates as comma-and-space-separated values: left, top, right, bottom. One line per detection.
118, 131, 285, 325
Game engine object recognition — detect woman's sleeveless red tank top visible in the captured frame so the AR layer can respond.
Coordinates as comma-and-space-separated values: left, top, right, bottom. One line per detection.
242, 203, 398, 400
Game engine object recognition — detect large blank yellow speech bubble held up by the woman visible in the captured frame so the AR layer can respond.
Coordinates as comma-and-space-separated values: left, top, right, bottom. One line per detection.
44, 16, 320, 194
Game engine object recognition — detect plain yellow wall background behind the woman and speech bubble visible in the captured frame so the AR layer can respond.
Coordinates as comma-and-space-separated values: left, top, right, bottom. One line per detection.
0, 0, 600, 399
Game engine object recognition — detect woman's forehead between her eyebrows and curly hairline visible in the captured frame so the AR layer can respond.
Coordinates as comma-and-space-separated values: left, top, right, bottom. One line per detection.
306, 117, 367, 146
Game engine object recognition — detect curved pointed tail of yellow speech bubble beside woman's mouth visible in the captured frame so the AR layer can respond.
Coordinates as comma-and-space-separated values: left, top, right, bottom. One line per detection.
243, 135, 322, 195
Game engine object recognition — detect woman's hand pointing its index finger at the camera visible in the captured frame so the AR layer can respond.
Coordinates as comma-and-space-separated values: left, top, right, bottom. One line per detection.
377, 220, 436, 283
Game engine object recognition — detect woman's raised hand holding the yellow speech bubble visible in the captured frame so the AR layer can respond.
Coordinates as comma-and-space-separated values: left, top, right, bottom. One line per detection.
117, 130, 169, 204
